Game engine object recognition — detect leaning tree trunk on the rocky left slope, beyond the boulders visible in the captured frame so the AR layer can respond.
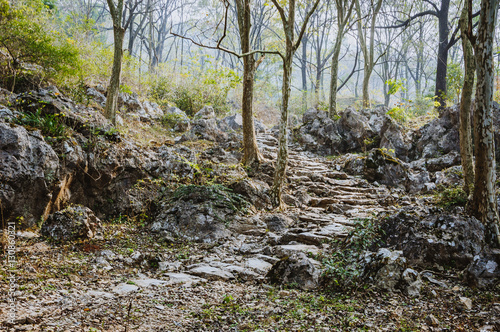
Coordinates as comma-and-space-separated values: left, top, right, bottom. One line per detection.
104, 0, 125, 125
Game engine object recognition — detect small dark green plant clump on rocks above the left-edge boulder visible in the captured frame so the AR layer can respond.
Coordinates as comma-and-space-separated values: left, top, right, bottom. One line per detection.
15, 109, 66, 137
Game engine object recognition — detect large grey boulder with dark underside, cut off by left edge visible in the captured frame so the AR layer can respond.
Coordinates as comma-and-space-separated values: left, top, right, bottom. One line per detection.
0, 122, 60, 227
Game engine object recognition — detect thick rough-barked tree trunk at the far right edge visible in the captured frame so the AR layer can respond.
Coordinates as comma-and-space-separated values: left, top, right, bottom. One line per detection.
471, 0, 500, 246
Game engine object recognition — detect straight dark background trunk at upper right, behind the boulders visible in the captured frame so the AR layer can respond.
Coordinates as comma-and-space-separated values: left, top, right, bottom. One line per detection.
435, 0, 450, 109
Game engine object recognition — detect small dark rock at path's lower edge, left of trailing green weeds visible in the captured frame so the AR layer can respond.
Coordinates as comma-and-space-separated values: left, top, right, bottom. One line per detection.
266, 252, 321, 290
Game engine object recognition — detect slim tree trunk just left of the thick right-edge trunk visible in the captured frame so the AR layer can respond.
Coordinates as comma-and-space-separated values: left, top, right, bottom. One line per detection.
459, 0, 476, 196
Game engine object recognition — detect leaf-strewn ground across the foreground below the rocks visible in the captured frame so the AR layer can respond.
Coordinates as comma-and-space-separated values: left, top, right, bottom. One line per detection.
0, 224, 500, 331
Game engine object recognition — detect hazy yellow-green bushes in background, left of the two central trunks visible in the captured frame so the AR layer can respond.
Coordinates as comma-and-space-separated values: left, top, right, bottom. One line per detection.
149, 61, 241, 116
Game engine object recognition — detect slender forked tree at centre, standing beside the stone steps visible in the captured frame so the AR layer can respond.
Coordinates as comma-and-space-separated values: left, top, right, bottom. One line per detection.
270, 0, 320, 208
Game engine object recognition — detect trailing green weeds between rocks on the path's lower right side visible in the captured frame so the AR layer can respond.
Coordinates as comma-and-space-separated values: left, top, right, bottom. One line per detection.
322, 219, 381, 290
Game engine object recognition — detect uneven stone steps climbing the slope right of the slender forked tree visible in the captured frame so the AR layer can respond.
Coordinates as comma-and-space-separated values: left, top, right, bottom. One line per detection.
257, 134, 392, 245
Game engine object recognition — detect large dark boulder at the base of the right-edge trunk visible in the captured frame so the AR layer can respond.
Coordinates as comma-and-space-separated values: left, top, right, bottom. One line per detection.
381, 211, 484, 268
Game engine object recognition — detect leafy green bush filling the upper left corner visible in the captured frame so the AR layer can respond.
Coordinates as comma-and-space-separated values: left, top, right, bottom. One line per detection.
0, 0, 78, 89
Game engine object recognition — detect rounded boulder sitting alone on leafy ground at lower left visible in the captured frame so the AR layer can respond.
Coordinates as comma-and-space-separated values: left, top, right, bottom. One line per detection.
41, 205, 101, 241
